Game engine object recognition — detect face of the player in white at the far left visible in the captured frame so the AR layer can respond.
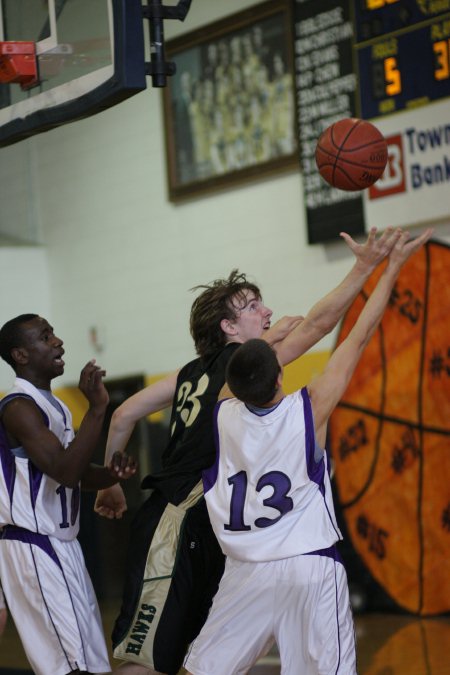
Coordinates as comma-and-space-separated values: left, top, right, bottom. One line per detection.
18, 316, 64, 379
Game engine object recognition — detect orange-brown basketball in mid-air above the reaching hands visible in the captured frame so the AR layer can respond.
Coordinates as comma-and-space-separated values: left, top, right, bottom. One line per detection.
315, 117, 388, 192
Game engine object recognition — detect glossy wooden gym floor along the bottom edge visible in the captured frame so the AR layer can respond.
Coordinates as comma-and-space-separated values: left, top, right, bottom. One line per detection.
0, 604, 450, 675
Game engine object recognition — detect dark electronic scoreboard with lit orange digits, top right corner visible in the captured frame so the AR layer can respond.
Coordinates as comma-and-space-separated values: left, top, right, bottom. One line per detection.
354, 0, 450, 119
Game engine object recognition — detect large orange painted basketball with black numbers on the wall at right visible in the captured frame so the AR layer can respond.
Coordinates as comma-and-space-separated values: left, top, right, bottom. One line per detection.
329, 241, 450, 616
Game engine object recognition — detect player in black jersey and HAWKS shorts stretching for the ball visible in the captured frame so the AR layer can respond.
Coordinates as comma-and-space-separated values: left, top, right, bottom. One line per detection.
95, 228, 400, 675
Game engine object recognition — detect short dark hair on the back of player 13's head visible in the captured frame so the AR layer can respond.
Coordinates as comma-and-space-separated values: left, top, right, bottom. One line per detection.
225, 338, 281, 406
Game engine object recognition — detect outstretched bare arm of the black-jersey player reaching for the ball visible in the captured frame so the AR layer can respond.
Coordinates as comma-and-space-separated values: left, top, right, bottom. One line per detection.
274, 228, 401, 365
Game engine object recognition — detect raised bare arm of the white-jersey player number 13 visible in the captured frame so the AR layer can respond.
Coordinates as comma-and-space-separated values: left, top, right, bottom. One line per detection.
308, 229, 432, 447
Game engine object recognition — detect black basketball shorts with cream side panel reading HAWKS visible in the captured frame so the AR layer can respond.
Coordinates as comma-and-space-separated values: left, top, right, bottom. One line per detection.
112, 482, 225, 675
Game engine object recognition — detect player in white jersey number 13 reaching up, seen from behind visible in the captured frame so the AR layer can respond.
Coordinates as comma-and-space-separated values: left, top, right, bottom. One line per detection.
185, 230, 431, 675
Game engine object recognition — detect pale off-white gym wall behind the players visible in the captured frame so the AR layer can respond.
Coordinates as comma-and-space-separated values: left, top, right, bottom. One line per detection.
0, 0, 446, 390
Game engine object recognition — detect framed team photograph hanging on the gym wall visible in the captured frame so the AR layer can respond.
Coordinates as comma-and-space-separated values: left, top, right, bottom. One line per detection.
163, 0, 299, 201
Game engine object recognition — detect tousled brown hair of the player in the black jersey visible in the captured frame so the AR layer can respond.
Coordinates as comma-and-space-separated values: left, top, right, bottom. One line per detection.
190, 270, 261, 357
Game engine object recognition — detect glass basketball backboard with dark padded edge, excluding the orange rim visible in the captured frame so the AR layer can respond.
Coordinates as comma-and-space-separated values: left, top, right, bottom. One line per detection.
0, 0, 147, 147
